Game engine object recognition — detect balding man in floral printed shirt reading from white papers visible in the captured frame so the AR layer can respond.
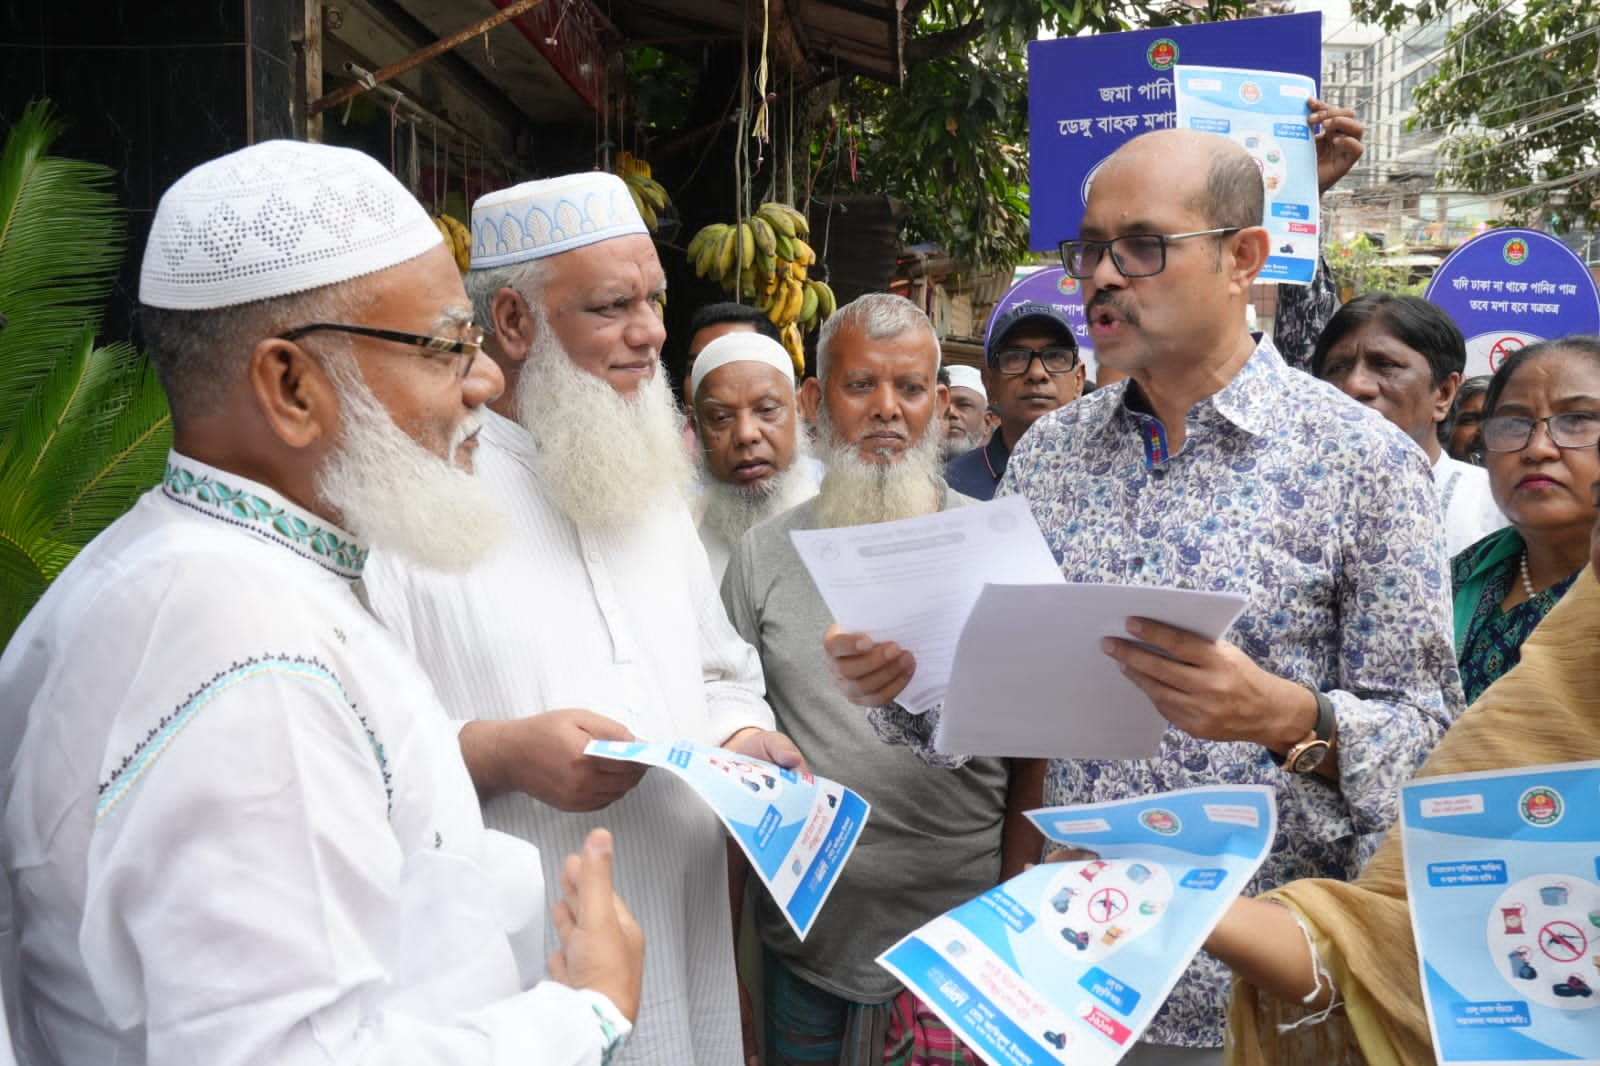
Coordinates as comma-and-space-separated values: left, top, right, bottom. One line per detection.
826, 130, 1462, 1066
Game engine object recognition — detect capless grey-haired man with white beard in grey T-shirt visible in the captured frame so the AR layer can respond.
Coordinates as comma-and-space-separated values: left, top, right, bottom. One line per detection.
720, 293, 1040, 1066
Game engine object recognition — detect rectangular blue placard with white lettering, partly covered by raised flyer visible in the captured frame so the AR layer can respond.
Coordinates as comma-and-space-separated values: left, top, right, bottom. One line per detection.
1027, 11, 1322, 251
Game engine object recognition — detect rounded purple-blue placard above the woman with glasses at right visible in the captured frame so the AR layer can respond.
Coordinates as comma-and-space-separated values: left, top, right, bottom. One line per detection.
1424, 229, 1600, 376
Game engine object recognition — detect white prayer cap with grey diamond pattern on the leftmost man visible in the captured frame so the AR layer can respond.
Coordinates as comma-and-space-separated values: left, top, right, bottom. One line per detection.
139, 141, 443, 311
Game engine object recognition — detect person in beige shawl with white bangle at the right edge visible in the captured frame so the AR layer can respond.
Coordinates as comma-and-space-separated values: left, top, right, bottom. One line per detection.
1206, 550, 1600, 1066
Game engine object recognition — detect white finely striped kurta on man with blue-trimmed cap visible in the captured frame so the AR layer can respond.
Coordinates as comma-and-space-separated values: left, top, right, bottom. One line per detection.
363, 415, 773, 1066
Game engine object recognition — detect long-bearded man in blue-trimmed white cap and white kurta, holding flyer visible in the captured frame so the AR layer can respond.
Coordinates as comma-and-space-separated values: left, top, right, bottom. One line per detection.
366, 173, 800, 1066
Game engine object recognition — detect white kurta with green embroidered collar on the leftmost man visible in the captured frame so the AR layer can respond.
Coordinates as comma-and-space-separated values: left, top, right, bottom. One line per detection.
0, 455, 626, 1066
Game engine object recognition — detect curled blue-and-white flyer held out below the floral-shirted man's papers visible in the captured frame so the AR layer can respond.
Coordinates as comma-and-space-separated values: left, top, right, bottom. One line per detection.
878, 786, 1277, 1066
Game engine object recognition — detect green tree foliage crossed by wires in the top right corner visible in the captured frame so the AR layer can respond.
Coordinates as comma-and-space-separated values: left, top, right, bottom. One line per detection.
1352, 0, 1600, 232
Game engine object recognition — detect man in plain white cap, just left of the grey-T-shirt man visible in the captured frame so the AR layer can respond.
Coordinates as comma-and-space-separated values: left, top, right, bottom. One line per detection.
690, 331, 816, 583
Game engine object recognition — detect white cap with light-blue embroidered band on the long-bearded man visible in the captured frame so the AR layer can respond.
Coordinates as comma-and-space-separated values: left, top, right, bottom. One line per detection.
472, 170, 650, 271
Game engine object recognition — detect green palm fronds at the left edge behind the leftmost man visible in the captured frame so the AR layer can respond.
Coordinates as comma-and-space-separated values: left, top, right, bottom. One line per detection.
0, 104, 171, 645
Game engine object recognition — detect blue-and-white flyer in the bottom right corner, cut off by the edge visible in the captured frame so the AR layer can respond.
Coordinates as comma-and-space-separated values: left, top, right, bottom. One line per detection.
1400, 762, 1600, 1063
